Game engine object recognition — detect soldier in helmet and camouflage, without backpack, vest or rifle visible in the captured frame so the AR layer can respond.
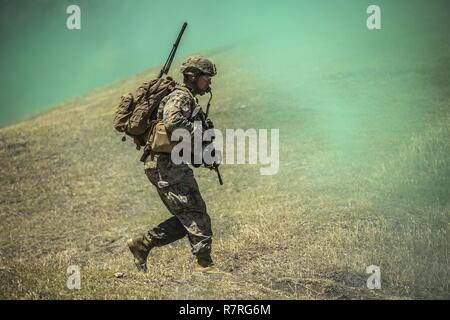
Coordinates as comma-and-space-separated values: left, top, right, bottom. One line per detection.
127, 56, 225, 273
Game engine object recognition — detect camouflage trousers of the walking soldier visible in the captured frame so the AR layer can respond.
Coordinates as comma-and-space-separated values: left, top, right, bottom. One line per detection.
145, 154, 212, 256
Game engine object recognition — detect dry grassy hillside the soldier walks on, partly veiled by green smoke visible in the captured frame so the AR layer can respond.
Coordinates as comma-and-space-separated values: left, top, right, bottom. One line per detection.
0, 45, 450, 299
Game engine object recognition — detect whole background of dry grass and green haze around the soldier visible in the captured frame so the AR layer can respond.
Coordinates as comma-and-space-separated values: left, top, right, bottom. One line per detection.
0, 0, 450, 299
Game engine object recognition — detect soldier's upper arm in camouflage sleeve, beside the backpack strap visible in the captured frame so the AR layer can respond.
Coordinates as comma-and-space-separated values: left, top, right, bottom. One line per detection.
163, 93, 194, 133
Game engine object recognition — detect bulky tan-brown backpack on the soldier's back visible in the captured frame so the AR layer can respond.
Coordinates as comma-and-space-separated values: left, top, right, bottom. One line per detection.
113, 77, 180, 150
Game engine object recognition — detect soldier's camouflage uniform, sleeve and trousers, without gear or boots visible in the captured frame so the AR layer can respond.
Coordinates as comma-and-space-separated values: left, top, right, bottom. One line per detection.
145, 86, 212, 258
